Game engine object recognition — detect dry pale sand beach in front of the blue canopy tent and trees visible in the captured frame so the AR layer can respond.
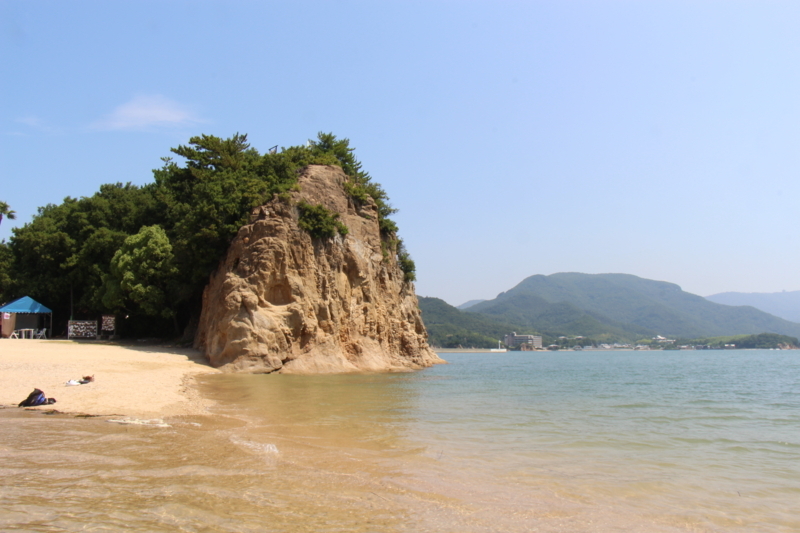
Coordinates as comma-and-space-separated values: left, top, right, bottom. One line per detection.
0, 339, 219, 418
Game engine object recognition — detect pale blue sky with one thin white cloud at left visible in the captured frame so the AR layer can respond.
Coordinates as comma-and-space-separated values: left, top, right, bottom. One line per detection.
0, 0, 800, 305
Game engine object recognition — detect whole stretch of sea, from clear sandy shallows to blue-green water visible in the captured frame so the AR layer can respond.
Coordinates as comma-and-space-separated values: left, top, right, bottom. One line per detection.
0, 350, 800, 532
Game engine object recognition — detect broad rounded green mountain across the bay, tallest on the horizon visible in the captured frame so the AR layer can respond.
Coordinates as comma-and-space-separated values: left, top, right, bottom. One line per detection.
465, 273, 800, 339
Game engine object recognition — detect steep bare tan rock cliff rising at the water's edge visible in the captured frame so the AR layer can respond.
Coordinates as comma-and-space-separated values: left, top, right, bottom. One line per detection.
195, 165, 443, 373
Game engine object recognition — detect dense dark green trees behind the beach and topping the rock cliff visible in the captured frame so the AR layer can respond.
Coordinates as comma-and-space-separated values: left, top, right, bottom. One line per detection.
0, 133, 413, 336
